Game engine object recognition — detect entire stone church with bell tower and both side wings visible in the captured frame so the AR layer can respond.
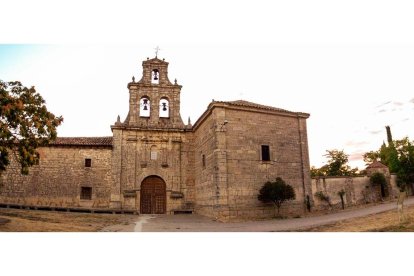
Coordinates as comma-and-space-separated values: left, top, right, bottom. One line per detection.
0, 57, 312, 221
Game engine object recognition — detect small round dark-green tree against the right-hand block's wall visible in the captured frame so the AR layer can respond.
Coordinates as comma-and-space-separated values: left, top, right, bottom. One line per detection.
257, 177, 296, 215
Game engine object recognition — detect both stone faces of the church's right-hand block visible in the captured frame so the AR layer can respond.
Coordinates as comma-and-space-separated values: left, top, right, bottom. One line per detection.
194, 106, 311, 221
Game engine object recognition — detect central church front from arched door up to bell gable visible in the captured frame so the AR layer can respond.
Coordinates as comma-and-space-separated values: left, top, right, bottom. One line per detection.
110, 56, 193, 211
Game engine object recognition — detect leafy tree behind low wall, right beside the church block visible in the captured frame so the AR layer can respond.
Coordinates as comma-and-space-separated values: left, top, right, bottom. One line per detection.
311, 149, 358, 177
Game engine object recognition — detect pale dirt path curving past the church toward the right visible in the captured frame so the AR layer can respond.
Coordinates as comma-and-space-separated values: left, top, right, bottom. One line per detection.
130, 198, 414, 232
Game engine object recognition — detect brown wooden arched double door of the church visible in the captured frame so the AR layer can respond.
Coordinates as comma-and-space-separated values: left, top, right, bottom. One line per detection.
140, 175, 167, 214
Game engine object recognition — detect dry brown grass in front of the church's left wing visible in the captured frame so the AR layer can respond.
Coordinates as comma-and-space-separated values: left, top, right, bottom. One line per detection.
0, 209, 138, 232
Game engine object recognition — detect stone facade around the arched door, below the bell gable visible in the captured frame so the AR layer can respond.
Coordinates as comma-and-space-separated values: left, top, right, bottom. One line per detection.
111, 129, 194, 214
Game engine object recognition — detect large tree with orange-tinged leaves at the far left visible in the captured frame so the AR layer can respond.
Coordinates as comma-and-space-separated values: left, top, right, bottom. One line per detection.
0, 80, 63, 174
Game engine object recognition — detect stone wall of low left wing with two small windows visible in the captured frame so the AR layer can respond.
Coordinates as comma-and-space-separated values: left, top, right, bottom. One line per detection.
0, 147, 112, 208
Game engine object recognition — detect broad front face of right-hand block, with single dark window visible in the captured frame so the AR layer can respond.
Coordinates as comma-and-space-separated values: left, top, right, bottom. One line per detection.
225, 109, 310, 219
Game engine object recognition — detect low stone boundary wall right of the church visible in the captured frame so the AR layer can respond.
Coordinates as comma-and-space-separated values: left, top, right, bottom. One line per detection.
311, 174, 399, 210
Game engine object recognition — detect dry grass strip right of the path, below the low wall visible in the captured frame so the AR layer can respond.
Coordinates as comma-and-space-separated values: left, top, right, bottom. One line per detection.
305, 206, 414, 232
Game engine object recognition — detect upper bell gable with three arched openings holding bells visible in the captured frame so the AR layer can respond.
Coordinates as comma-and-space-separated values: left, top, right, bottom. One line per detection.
124, 57, 185, 129
